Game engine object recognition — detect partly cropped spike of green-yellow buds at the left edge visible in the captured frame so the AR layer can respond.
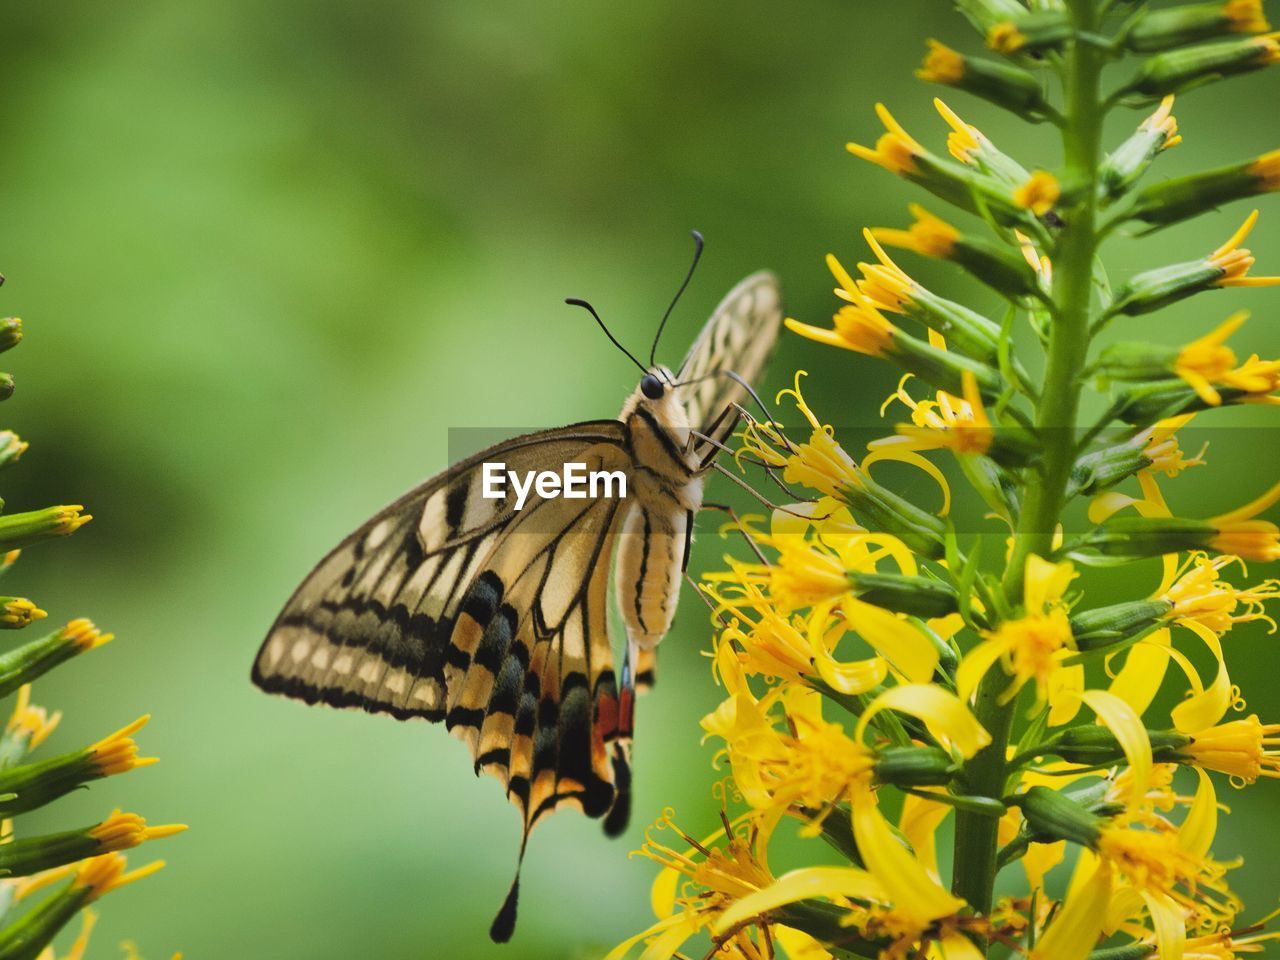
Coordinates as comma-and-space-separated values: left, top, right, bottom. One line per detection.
0, 284, 186, 960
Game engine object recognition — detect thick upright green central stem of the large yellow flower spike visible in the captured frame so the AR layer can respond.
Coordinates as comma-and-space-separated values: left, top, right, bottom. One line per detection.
952, 0, 1106, 913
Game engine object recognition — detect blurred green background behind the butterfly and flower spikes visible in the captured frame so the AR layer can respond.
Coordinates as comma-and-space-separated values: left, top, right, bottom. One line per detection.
0, 0, 1280, 960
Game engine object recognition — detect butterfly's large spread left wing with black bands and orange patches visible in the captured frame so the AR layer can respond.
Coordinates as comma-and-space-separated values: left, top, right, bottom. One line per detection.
253, 420, 631, 836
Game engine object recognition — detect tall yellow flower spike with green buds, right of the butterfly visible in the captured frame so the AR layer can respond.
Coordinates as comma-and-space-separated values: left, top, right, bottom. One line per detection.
609, 0, 1280, 960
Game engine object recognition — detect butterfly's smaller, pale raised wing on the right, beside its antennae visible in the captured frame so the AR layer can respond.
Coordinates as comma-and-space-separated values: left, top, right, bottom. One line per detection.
676, 270, 782, 450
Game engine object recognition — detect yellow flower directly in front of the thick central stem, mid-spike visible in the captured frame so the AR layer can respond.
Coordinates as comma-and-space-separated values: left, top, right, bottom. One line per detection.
956, 554, 1075, 701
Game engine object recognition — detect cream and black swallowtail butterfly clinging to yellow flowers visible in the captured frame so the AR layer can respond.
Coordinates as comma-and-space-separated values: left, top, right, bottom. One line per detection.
252, 232, 782, 942
